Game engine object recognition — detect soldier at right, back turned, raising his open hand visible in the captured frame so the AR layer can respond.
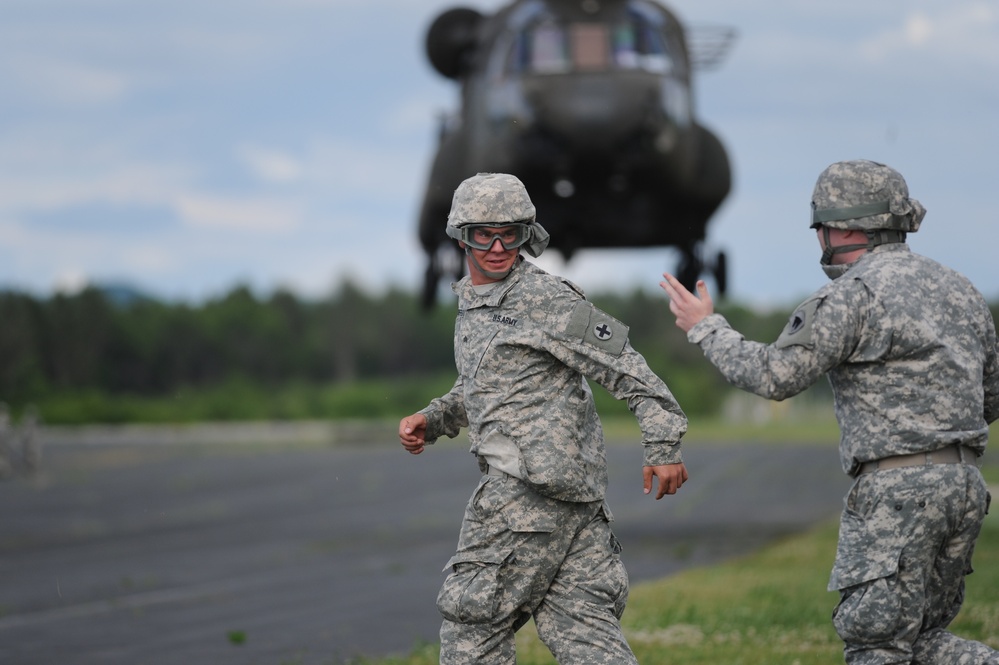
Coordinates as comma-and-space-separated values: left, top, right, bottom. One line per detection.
661, 160, 999, 665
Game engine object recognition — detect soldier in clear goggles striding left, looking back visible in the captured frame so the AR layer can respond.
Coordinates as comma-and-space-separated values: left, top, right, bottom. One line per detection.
399, 174, 687, 665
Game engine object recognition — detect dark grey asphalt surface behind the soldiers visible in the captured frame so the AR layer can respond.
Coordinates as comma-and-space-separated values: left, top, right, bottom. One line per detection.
0, 426, 849, 665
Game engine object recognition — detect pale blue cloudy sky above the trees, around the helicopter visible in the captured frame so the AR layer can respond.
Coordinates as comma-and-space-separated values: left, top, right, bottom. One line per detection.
0, 0, 999, 306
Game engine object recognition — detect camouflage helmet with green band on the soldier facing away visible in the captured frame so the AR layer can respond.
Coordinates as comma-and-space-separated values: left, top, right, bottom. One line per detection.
812, 159, 926, 233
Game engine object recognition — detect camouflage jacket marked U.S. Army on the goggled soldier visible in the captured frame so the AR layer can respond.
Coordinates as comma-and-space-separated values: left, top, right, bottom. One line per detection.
421, 261, 687, 502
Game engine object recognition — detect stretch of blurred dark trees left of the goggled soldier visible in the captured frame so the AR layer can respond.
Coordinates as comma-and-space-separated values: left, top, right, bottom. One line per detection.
0, 282, 453, 402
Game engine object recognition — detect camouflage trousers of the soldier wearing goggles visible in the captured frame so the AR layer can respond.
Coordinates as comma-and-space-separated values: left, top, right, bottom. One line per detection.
437, 476, 637, 665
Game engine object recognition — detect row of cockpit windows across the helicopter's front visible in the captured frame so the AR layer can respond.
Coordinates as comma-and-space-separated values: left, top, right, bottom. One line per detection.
506, 9, 674, 74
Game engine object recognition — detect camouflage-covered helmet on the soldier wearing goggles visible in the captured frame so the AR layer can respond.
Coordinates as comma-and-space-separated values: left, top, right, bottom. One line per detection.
447, 173, 537, 231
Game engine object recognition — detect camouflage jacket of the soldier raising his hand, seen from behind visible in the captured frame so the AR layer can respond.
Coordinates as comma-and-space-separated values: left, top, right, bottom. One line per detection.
687, 243, 999, 475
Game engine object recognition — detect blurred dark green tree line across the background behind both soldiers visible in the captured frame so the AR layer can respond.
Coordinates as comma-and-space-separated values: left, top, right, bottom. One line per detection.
9, 281, 995, 422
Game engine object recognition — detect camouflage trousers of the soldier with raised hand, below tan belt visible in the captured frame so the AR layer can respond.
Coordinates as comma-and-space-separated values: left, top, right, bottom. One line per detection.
829, 464, 999, 665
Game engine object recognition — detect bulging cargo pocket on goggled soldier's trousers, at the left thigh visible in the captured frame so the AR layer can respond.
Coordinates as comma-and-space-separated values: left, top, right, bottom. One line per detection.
437, 552, 510, 623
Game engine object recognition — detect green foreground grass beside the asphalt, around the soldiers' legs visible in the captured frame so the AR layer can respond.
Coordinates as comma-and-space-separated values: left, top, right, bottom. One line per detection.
362, 463, 999, 665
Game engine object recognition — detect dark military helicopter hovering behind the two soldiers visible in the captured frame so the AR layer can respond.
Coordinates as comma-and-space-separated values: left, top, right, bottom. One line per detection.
419, 0, 735, 309
